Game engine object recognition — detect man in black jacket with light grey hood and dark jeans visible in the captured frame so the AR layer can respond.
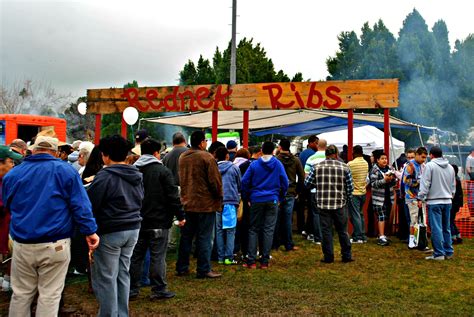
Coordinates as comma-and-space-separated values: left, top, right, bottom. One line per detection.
130, 139, 185, 299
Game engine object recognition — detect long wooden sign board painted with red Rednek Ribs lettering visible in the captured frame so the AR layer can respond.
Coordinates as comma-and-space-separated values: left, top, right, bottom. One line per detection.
87, 79, 398, 114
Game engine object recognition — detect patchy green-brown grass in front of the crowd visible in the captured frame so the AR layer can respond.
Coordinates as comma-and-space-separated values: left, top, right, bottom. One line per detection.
0, 237, 474, 316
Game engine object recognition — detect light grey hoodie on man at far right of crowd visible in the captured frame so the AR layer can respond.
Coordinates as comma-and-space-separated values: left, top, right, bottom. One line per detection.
418, 157, 456, 205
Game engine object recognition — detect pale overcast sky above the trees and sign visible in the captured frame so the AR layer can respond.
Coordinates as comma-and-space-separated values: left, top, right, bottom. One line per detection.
0, 0, 474, 96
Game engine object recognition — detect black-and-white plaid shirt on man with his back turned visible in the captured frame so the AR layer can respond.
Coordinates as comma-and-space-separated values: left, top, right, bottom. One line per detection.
304, 159, 354, 210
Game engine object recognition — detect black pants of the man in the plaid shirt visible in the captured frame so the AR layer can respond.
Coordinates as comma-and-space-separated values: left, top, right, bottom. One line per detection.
319, 206, 352, 261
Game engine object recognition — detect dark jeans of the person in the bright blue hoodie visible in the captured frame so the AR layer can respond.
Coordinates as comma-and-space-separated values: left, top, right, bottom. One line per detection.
248, 201, 278, 264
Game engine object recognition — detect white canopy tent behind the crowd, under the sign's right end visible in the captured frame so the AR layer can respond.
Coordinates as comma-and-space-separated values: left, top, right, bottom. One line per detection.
318, 125, 405, 163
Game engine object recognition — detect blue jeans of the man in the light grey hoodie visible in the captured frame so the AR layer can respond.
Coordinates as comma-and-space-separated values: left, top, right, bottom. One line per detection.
428, 204, 454, 257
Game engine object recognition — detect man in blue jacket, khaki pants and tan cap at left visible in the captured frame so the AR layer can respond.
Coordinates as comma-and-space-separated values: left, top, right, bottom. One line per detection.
3, 136, 99, 316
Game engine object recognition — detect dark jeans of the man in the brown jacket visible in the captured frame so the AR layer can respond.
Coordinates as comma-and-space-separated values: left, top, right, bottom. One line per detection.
176, 212, 216, 275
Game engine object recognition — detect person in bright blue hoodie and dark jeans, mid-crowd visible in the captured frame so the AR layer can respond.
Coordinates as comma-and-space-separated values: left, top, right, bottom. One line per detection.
241, 141, 288, 269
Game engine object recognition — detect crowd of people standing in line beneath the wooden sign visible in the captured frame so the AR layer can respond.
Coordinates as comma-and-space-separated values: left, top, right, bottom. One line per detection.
0, 130, 463, 316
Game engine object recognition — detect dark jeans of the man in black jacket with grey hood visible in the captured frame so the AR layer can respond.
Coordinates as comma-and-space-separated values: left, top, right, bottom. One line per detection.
130, 229, 169, 296
